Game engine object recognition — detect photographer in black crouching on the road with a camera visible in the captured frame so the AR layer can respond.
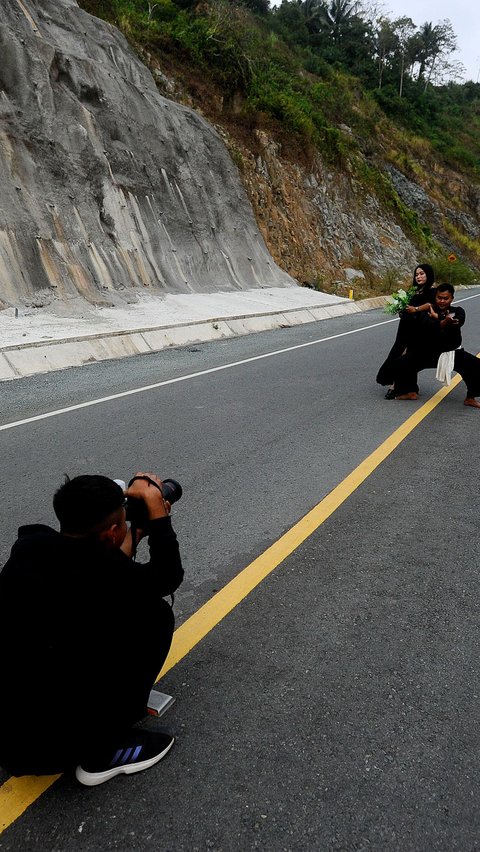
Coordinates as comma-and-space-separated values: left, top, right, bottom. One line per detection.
0, 473, 183, 785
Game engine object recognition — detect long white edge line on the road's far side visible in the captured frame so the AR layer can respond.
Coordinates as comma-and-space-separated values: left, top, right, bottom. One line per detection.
0, 294, 480, 432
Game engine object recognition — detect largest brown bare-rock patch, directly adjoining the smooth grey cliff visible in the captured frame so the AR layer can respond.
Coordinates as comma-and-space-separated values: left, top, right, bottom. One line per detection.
239, 131, 416, 285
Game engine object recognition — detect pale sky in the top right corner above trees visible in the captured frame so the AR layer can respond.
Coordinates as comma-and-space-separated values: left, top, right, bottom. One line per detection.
381, 0, 480, 83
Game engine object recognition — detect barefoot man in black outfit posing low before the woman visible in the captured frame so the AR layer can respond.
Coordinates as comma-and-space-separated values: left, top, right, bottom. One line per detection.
393, 284, 480, 408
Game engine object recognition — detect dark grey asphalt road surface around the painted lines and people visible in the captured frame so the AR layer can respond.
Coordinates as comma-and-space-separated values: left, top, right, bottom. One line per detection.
0, 291, 480, 852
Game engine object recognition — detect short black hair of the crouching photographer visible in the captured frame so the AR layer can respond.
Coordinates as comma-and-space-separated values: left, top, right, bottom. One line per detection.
53, 475, 125, 535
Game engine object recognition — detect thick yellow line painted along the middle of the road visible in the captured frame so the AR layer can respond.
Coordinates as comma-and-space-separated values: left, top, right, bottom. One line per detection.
0, 376, 461, 834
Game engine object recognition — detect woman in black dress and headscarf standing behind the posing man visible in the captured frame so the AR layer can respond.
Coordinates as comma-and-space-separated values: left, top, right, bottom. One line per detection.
377, 263, 435, 399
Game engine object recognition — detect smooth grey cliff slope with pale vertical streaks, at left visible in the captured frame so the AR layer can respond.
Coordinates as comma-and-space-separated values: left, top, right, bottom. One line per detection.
0, 0, 294, 306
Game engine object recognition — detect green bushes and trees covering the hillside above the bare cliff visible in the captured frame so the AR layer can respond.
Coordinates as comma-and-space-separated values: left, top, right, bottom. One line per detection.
81, 0, 480, 280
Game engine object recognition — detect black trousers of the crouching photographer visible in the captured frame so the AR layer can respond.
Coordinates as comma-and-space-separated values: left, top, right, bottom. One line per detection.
0, 600, 175, 775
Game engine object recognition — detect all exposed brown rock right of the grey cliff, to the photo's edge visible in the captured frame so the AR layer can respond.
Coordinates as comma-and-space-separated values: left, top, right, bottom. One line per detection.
225, 123, 480, 295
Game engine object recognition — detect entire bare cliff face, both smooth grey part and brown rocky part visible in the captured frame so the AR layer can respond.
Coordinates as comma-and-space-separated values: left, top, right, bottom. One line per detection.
0, 0, 480, 308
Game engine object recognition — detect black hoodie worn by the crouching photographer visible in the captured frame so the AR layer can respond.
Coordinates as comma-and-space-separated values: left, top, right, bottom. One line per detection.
0, 518, 183, 765
